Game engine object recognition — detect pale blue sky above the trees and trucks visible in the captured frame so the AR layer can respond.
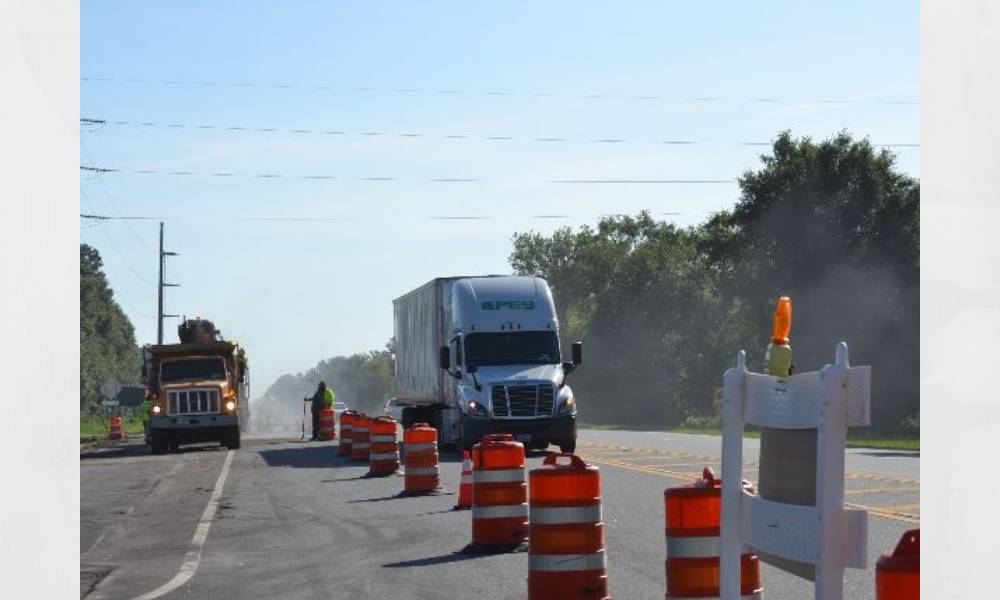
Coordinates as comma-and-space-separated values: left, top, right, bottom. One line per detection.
80, 0, 920, 394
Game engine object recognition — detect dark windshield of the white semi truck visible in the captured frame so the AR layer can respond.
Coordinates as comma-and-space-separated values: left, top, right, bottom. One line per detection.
465, 331, 559, 369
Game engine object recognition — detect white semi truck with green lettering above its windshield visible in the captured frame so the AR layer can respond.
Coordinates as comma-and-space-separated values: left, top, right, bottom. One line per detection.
387, 275, 583, 452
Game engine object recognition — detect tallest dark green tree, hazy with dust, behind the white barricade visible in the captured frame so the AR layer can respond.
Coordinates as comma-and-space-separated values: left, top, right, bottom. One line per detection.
700, 132, 920, 431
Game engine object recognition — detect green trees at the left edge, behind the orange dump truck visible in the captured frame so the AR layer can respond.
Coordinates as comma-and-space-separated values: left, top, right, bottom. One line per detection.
80, 244, 142, 412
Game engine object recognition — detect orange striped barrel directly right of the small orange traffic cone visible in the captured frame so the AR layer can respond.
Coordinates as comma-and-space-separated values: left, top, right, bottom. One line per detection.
472, 434, 528, 546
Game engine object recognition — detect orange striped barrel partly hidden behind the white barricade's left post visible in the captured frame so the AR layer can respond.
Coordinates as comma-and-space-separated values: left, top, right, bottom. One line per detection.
663, 468, 762, 600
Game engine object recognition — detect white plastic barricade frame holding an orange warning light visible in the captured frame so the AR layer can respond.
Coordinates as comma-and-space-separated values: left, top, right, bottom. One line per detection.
720, 342, 871, 600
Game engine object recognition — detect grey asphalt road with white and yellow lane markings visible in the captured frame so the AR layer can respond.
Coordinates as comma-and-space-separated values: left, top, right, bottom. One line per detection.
80, 430, 920, 600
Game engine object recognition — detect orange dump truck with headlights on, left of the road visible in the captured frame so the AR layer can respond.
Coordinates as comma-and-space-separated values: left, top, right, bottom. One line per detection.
142, 319, 250, 454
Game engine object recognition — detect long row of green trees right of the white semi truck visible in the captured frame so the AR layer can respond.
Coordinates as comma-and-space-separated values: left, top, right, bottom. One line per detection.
510, 132, 920, 435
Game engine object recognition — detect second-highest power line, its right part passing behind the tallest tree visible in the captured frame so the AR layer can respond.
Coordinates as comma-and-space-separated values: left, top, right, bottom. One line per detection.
80, 117, 920, 148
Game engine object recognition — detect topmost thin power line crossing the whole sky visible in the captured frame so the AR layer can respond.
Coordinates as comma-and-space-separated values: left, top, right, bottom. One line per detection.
80, 77, 920, 106
